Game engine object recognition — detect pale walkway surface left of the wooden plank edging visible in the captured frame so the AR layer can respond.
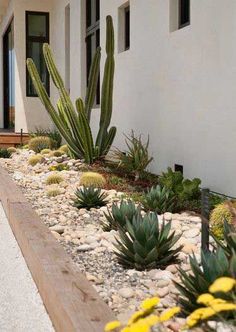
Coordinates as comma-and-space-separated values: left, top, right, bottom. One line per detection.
0, 203, 54, 332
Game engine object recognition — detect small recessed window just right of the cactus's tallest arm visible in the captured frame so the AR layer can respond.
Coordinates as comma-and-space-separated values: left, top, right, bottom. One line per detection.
118, 2, 130, 52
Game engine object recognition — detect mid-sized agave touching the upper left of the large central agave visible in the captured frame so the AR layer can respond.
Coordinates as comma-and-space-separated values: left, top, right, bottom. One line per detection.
103, 200, 140, 231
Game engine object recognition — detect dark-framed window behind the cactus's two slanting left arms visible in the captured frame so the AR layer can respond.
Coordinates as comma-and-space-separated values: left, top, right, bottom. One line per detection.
26, 12, 50, 97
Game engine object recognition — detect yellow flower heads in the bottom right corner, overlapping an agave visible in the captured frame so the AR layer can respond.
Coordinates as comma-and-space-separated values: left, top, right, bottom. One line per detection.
186, 277, 236, 331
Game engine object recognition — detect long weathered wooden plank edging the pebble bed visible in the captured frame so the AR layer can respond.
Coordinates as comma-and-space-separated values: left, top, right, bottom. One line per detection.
0, 168, 114, 332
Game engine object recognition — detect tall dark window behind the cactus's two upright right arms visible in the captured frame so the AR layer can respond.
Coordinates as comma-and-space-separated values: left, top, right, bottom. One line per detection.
86, 0, 100, 105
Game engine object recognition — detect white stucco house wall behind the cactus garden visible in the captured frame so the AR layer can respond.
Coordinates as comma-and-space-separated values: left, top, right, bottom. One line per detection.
0, 0, 236, 196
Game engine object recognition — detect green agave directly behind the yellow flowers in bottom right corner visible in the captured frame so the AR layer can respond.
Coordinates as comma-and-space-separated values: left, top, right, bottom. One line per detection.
174, 248, 236, 315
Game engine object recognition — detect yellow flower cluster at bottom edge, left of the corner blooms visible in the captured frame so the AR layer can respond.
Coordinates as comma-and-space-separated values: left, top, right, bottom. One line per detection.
104, 297, 180, 332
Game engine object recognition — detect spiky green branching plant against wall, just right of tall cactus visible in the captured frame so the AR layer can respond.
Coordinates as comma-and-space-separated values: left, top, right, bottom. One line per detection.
114, 131, 153, 180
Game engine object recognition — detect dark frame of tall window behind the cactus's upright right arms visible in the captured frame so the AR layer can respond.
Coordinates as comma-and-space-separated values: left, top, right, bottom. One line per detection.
85, 0, 101, 107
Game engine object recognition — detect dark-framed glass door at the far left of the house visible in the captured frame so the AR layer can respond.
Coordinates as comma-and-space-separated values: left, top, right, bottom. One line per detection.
3, 20, 15, 129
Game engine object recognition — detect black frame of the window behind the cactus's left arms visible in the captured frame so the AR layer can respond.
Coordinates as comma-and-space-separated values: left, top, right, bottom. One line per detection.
25, 11, 50, 97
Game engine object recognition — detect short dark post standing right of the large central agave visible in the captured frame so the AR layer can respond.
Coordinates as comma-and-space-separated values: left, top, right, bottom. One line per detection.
201, 188, 210, 251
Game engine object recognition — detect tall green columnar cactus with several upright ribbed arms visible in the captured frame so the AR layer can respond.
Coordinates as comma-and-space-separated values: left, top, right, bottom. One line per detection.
27, 16, 116, 164
